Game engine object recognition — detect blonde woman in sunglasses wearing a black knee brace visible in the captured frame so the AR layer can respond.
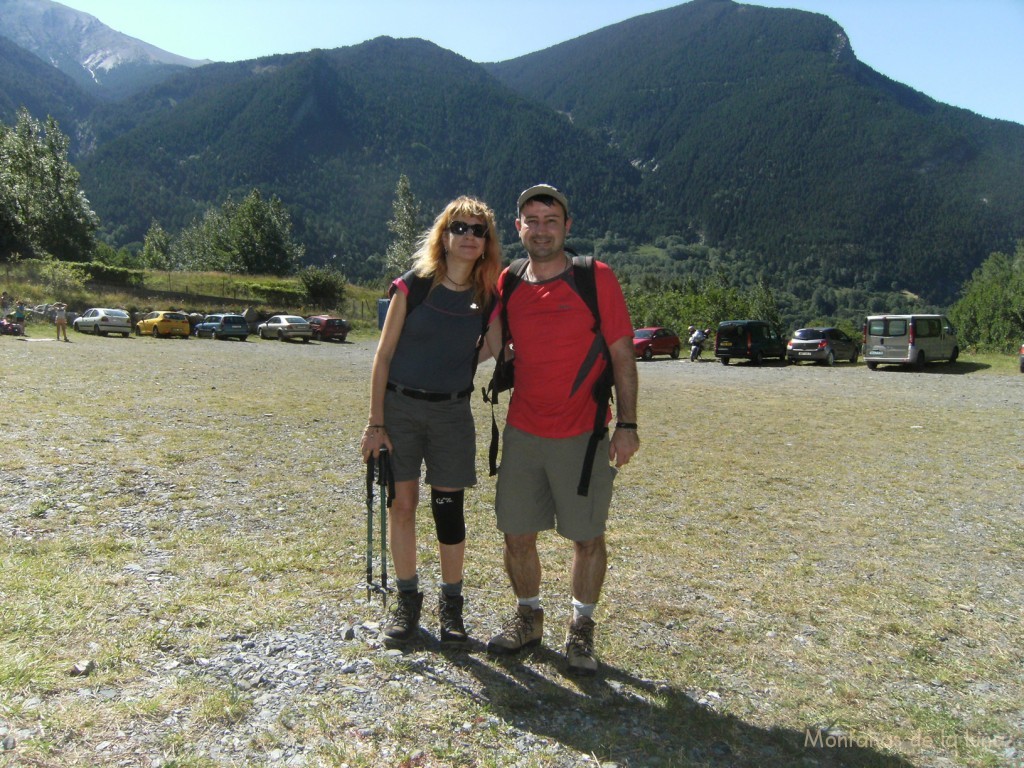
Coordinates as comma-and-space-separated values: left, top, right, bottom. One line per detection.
360, 197, 502, 645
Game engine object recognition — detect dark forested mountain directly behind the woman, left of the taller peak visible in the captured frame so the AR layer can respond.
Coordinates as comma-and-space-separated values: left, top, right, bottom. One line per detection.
79, 38, 640, 275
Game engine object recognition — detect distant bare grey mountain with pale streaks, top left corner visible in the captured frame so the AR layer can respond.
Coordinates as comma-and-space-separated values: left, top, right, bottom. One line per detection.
0, 0, 208, 98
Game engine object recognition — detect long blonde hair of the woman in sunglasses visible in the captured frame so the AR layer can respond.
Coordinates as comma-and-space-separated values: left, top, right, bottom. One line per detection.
413, 195, 502, 307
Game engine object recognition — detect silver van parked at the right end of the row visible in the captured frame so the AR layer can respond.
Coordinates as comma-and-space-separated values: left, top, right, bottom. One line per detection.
862, 314, 959, 371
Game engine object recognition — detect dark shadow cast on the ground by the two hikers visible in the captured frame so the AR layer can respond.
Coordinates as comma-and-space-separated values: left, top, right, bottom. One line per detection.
409, 649, 912, 768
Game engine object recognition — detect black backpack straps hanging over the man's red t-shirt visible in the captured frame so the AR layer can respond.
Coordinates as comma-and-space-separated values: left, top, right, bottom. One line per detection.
483, 248, 614, 496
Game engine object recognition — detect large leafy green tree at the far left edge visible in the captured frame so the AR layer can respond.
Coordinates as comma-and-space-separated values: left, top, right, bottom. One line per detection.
0, 109, 98, 261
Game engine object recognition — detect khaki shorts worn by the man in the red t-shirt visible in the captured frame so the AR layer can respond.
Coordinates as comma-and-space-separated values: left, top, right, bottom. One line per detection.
495, 426, 617, 542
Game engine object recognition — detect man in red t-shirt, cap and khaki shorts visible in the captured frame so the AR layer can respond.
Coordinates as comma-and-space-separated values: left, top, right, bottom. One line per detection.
487, 184, 640, 675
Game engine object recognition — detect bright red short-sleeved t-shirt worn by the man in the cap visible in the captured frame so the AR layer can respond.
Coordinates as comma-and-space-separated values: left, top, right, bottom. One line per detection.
499, 261, 633, 437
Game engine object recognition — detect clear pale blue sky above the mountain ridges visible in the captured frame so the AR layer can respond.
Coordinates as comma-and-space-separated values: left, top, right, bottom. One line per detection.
62, 0, 1024, 125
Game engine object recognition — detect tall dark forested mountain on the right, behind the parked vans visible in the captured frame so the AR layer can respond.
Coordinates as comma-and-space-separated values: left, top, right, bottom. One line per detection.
487, 0, 1024, 302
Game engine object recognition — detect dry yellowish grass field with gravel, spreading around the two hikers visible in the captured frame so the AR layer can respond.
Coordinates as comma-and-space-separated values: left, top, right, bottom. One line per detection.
0, 334, 1024, 766
